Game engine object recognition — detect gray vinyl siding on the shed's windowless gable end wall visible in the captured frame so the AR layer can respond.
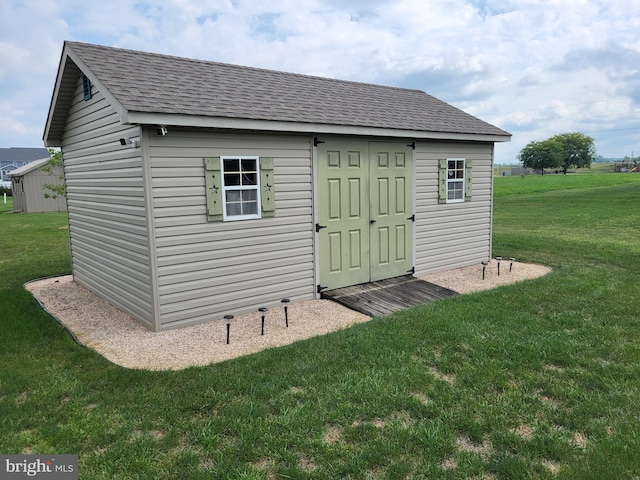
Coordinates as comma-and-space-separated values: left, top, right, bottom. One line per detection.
62, 80, 154, 329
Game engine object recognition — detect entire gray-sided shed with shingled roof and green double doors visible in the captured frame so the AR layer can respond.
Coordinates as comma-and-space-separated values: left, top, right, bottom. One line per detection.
44, 42, 510, 331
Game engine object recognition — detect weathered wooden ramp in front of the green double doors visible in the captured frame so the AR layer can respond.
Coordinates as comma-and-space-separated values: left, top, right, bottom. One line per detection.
321, 275, 458, 317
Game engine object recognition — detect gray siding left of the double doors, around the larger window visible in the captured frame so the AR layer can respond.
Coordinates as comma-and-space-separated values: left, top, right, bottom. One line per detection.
148, 128, 314, 329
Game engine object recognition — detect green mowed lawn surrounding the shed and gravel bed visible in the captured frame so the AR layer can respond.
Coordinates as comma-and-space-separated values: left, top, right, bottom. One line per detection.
0, 174, 640, 479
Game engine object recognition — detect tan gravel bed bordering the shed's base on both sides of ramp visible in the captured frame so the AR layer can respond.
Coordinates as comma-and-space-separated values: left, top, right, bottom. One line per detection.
25, 260, 551, 370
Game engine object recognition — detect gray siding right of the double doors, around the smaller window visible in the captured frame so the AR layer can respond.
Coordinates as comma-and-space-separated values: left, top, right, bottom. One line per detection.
415, 142, 493, 275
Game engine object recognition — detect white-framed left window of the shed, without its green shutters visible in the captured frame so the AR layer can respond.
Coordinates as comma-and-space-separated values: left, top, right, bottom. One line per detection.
221, 157, 260, 220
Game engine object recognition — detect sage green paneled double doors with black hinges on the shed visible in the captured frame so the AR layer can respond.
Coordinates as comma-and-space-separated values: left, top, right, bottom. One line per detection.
317, 140, 413, 289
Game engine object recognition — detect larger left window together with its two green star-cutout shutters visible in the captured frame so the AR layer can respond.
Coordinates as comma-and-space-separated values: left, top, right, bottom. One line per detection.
204, 155, 275, 222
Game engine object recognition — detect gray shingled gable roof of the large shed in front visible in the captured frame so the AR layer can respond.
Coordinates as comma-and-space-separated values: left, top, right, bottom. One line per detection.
45, 42, 510, 145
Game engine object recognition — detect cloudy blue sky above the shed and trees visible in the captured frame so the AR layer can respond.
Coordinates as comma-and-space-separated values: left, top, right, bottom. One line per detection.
0, 0, 640, 163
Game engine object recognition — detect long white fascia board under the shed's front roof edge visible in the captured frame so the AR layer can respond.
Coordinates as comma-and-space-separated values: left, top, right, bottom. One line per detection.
126, 112, 511, 142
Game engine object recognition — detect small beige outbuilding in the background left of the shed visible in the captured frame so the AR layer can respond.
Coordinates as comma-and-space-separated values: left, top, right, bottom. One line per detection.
11, 157, 67, 213
